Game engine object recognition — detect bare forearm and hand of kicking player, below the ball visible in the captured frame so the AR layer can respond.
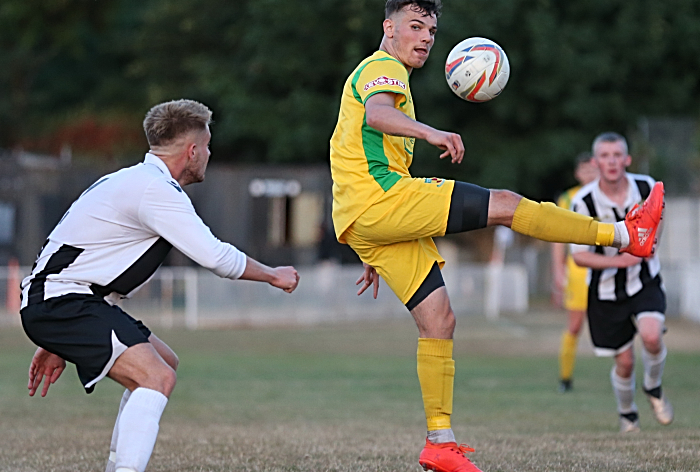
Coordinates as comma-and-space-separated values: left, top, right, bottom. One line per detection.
365, 92, 464, 164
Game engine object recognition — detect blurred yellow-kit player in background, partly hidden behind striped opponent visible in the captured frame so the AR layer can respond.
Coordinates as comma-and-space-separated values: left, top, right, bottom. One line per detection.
552, 152, 598, 393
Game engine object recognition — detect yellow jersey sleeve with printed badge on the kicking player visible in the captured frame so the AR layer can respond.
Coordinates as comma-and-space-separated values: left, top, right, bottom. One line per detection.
353, 59, 408, 104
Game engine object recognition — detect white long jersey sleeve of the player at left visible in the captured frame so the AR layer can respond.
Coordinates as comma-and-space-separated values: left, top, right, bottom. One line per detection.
139, 179, 247, 279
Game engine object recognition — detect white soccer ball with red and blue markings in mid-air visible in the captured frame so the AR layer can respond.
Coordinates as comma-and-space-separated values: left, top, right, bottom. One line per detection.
445, 38, 510, 103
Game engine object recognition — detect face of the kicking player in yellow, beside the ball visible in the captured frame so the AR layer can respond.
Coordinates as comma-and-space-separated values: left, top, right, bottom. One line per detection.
385, 5, 437, 70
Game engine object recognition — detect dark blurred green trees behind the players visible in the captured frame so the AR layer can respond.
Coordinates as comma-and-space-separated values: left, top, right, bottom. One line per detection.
0, 0, 700, 198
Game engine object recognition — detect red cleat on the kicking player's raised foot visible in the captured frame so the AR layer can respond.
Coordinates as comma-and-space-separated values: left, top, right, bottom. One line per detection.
620, 182, 665, 257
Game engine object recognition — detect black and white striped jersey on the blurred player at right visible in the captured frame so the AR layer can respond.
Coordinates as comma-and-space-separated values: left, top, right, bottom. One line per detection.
571, 173, 661, 301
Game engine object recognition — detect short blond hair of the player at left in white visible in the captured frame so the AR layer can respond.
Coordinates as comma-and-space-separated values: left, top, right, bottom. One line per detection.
143, 99, 212, 146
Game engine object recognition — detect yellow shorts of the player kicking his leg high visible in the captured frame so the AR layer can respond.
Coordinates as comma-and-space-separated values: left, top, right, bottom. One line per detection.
343, 178, 454, 305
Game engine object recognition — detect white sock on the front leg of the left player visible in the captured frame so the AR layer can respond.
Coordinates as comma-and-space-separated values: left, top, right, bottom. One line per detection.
116, 388, 168, 472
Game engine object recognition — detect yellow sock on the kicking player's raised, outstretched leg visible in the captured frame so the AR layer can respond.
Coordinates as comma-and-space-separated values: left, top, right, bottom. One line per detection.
511, 198, 615, 246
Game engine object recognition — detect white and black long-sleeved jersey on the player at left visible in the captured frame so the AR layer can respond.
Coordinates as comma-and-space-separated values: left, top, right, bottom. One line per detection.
22, 153, 246, 308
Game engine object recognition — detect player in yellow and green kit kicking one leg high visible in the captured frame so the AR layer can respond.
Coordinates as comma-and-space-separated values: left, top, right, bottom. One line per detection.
330, 0, 663, 472
